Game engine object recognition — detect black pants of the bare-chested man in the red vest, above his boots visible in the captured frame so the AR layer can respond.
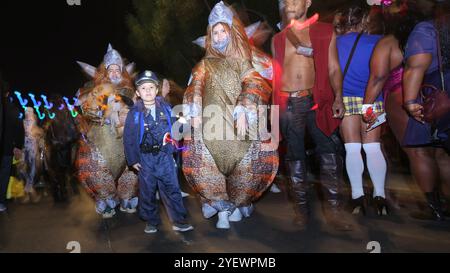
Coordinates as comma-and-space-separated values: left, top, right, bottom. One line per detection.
281, 96, 338, 161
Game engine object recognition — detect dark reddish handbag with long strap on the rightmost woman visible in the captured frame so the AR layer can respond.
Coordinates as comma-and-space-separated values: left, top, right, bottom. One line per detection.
420, 26, 450, 123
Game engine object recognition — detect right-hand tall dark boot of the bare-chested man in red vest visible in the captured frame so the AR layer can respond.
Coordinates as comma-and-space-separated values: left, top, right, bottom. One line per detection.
319, 154, 352, 231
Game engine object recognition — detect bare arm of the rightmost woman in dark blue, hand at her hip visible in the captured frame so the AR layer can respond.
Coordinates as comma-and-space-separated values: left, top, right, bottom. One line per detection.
403, 53, 432, 121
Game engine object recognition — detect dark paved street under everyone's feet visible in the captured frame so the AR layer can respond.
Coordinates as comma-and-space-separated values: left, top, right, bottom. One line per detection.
0, 169, 450, 253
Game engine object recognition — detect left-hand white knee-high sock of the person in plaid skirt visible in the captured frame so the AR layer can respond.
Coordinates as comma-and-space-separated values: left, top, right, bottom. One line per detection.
345, 143, 364, 199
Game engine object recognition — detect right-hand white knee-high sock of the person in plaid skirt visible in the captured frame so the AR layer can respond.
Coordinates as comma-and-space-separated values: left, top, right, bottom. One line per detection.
363, 143, 387, 198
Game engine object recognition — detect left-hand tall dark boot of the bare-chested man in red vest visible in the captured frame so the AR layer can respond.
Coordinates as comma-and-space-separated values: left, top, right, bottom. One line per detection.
287, 160, 310, 229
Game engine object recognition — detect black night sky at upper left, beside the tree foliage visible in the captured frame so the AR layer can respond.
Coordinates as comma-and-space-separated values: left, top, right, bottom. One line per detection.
0, 0, 133, 95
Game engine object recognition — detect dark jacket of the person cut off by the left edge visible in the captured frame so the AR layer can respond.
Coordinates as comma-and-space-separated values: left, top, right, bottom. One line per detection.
0, 97, 25, 156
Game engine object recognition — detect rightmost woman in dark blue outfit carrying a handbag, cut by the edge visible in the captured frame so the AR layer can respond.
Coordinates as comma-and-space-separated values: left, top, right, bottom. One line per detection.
403, 0, 450, 220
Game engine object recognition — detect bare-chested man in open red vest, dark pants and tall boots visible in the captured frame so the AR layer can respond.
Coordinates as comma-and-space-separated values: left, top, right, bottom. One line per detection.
272, 0, 351, 230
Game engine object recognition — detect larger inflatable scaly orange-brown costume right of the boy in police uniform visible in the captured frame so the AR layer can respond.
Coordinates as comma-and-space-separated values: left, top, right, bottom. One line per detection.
183, 2, 279, 218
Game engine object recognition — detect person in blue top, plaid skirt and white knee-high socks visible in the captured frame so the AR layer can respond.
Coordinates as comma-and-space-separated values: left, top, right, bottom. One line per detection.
335, 2, 388, 215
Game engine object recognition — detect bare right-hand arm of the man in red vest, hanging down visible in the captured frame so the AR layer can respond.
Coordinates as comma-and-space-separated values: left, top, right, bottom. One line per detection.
328, 30, 345, 118
